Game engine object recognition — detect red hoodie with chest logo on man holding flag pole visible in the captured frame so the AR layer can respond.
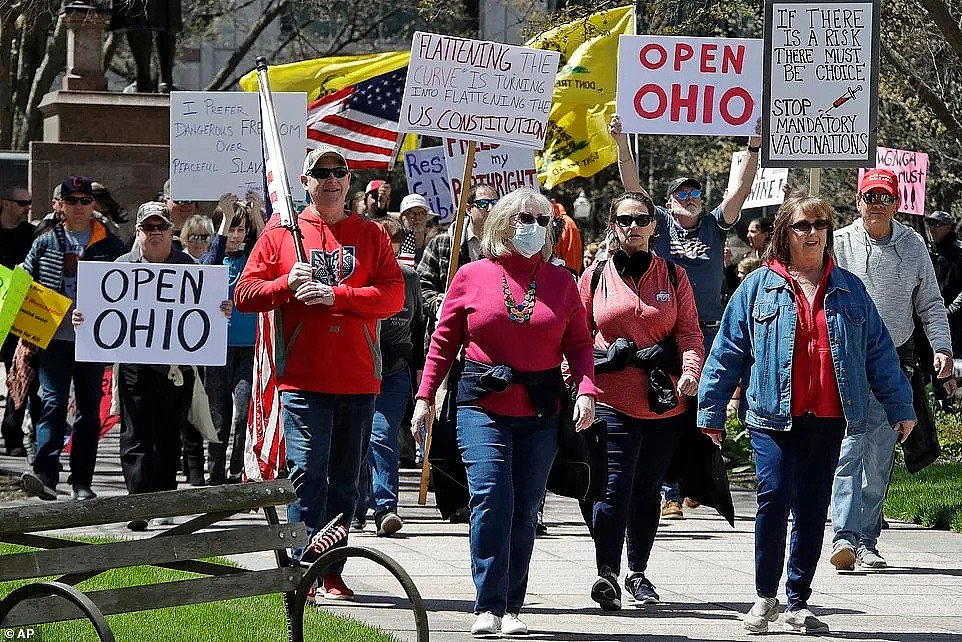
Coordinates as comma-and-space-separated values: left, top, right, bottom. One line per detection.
234, 207, 404, 394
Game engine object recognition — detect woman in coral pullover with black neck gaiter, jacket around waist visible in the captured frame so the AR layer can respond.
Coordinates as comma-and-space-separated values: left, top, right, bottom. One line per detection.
579, 192, 705, 611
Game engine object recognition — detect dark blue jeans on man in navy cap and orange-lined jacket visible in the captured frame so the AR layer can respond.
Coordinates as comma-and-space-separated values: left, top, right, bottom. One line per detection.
33, 339, 104, 487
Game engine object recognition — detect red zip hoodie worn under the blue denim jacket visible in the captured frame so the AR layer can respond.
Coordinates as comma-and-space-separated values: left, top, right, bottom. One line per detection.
765, 256, 844, 418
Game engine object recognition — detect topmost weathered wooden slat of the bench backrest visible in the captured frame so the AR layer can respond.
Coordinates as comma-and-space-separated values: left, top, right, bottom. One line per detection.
0, 479, 296, 534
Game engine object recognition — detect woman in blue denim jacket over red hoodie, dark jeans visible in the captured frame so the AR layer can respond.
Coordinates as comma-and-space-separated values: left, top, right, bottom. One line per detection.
698, 196, 915, 634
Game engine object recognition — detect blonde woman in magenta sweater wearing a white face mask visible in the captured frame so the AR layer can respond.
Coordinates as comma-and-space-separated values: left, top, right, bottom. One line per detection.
412, 188, 597, 636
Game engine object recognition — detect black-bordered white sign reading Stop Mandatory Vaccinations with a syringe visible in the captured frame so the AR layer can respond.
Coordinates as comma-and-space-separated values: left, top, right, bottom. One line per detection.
762, 0, 880, 167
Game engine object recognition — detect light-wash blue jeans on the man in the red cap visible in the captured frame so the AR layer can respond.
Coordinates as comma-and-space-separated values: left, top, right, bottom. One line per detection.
832, 395, 899, 548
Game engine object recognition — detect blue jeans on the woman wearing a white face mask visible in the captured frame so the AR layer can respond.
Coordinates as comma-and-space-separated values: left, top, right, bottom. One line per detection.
458, 406, 559, 616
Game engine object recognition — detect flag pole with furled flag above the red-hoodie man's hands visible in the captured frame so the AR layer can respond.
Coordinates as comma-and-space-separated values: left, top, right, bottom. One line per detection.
256, 56, 307, 263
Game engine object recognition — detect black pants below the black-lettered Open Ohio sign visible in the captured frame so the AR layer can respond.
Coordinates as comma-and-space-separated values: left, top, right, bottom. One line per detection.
118, 364, 194, 495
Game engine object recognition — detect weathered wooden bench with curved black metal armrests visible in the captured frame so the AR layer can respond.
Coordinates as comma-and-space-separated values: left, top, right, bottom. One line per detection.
0, 480, 428, 642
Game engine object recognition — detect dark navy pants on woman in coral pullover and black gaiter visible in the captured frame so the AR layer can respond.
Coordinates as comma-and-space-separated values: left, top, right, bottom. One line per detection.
592, 406, 685, 575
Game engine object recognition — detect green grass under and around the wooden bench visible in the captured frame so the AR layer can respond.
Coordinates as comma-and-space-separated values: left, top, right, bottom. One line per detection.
0, 540, 397, 642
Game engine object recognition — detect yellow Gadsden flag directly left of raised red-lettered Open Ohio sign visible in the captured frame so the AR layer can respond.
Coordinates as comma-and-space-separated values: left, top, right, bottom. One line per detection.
527, 6, 633, 188
